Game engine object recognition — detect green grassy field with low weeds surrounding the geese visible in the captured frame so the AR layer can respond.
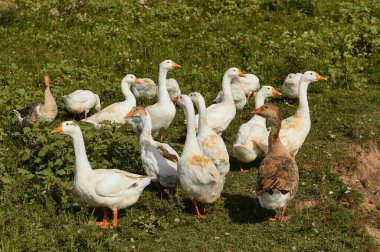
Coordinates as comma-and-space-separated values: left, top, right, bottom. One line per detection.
0, 0, 380, 251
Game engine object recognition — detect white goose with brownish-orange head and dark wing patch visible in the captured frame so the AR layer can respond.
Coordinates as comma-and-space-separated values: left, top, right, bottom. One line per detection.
125, 107, 179, 191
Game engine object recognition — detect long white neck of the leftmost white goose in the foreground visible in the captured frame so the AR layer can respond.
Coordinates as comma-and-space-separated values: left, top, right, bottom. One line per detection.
71, 131, 92, 176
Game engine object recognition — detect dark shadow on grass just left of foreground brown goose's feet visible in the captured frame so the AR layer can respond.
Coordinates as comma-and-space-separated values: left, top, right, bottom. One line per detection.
222, 193, 266, 224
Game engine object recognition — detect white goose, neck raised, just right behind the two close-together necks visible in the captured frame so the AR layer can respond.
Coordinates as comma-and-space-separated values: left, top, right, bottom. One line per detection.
195, 67, 244, 135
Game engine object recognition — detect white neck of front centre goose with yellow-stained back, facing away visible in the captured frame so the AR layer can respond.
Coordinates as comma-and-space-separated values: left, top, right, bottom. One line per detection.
182, 104, 202, 155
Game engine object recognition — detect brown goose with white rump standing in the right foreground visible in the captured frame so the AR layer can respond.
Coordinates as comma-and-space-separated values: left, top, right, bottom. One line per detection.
252, 104, 299, 222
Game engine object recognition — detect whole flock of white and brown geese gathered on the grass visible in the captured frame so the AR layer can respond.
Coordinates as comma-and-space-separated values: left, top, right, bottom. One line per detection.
14, 60, 326, 228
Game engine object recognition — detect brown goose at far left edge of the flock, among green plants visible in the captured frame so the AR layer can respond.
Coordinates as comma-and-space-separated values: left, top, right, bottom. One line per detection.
13, 75, 58, 126
